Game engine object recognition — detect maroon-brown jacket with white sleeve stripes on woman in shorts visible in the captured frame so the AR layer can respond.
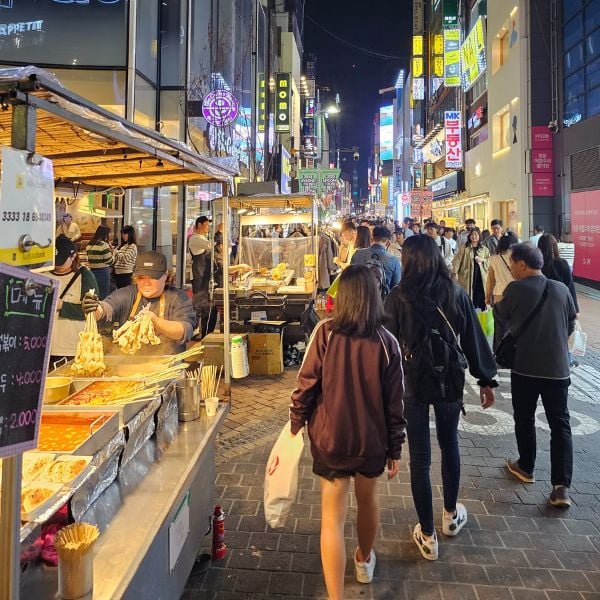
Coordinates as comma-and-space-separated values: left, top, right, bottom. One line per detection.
290, 320, 406, 473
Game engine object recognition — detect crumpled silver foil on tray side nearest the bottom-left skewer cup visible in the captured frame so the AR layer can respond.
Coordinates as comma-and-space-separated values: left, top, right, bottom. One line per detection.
71, 429, 125, 521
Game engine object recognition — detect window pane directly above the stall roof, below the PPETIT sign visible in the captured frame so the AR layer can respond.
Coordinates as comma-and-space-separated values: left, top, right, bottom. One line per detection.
52, 69, 125, 117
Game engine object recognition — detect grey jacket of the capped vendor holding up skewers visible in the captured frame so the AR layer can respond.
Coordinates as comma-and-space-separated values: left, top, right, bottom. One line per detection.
99, 285, 196, 355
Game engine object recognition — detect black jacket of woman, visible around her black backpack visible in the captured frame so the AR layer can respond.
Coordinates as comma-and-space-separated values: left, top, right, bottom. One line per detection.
384, 284, 497, 401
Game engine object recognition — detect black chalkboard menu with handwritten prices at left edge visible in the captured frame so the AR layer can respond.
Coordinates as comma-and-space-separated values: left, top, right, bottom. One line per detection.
0, 263, 58, 457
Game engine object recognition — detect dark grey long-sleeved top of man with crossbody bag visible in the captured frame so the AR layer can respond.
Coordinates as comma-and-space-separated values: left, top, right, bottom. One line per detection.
494, 275, 577, 379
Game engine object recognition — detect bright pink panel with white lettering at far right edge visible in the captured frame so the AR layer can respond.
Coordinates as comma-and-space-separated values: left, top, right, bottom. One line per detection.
571, 190, 600, 281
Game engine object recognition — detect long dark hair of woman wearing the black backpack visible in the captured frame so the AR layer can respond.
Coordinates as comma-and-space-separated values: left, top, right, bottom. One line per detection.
398, 235, 456, 316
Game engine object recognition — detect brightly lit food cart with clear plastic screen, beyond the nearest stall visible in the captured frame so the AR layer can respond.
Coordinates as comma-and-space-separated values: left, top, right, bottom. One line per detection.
215, 194, 319, 343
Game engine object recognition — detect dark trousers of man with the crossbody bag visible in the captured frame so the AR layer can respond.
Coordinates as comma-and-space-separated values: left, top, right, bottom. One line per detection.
510, 373, 573, 487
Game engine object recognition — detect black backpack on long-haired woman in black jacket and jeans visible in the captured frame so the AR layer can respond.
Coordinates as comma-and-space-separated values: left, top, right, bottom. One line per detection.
400, 307, 468, 404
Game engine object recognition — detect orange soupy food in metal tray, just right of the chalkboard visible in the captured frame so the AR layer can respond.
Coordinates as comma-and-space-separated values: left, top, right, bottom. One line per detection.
38, 414, 110, 452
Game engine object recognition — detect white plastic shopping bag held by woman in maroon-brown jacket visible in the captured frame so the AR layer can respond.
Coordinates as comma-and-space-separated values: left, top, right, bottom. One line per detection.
265, 421, 304, 527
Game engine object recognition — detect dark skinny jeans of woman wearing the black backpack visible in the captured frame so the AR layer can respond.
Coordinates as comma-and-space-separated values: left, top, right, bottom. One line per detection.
404, 400, 461, 535
